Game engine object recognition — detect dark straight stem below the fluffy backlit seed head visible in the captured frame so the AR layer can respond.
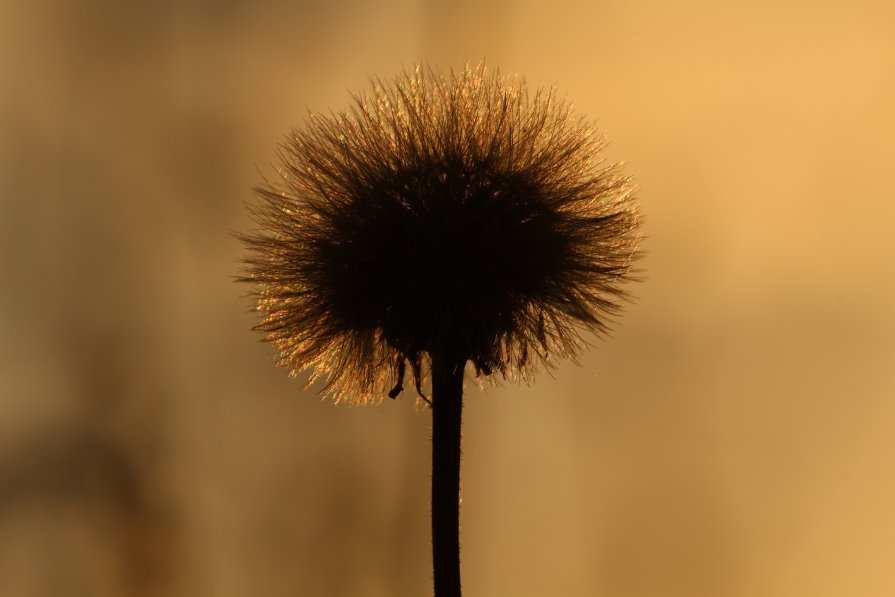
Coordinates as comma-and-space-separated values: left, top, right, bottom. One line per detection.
432, 355, 466, 597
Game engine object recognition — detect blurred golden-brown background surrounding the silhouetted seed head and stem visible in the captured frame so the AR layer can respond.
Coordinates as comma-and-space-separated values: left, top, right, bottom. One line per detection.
0, 0, 895, 597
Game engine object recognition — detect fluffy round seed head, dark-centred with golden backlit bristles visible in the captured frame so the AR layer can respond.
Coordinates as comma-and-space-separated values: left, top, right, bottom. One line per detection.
241, 66, 640, 402
